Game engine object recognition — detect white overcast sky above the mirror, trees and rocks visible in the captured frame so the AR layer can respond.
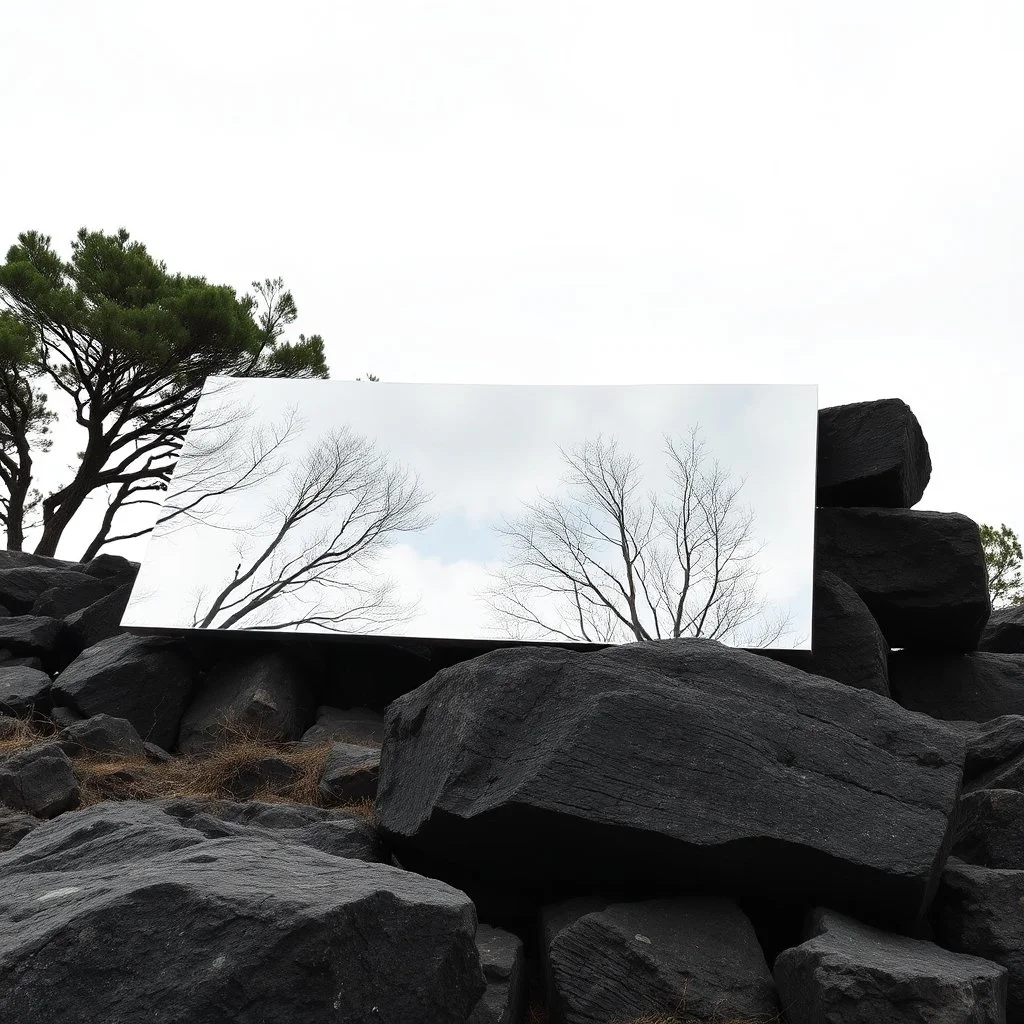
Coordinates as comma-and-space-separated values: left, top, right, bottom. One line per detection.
0, 0, 1024, 577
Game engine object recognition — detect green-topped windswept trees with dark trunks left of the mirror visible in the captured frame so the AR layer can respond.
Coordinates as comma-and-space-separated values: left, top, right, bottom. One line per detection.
0, 227, 328, 559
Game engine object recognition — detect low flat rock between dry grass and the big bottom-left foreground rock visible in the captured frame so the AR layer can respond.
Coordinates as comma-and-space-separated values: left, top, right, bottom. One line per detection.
153, 799, 385, 863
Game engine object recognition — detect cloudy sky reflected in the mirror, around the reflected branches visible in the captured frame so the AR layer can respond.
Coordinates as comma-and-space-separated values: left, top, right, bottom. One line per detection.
125, 378, 817, 647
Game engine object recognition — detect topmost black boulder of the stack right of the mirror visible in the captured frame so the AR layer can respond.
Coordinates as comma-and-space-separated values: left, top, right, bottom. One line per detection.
816, 398, 932, 509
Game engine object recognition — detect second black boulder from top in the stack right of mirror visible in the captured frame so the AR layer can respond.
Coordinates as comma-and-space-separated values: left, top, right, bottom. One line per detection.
814, 508, 989, 651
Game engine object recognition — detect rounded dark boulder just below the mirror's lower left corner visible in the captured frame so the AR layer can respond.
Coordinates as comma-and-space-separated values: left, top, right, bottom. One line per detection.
52, 634, 196, 750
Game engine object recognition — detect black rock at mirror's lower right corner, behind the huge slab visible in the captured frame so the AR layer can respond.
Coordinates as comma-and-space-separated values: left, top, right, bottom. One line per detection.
761, 571, 889, 696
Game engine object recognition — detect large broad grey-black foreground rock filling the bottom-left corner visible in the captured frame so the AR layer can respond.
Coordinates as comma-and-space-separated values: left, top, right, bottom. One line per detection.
0, 811, 485, 1024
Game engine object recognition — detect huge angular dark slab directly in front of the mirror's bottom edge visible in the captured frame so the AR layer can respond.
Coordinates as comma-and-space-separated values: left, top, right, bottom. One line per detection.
376, 640, 965, 920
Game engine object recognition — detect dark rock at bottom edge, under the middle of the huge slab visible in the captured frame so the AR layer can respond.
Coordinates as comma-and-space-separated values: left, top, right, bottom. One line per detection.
542, 896, 778, 1024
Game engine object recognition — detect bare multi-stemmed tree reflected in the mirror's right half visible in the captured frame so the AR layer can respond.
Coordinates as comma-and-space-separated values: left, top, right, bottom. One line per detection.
485, 427, 790, 647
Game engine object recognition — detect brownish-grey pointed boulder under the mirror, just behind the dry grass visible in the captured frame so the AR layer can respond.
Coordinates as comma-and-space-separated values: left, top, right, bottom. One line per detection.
178, 650, 313, 754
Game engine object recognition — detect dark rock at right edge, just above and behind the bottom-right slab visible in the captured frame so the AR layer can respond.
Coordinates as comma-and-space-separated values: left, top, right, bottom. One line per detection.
932, 858, 1024, 1024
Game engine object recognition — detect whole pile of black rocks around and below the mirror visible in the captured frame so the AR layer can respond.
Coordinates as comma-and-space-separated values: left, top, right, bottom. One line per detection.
0, 399, 1024, 1024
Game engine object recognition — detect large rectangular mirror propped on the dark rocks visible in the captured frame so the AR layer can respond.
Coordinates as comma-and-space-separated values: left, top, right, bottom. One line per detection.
122, 377, 817, 649
